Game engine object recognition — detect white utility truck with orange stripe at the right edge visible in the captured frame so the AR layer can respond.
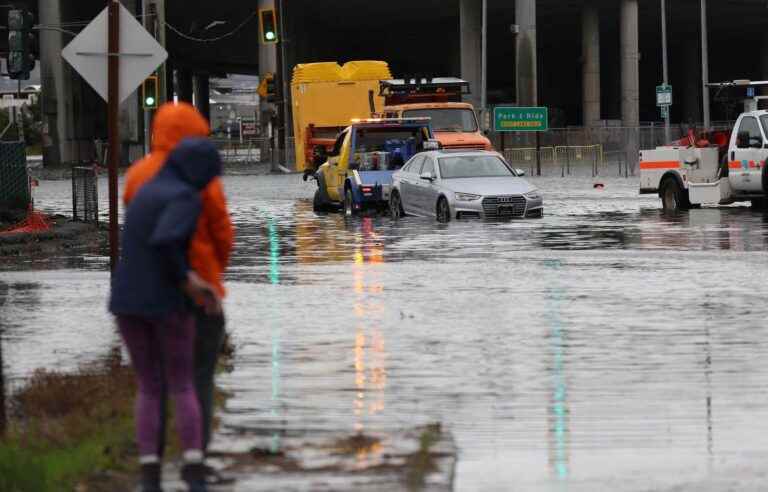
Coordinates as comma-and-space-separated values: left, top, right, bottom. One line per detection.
640, 111, 768, 210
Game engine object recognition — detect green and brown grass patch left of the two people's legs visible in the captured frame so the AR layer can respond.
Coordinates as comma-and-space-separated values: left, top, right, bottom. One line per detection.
0, 350, 136, 492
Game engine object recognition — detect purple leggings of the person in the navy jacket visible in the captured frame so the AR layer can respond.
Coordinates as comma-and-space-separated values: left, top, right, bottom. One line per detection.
117, 313, 203, 456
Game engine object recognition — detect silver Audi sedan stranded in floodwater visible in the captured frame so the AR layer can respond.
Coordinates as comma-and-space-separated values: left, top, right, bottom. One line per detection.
389, 150, 544, 222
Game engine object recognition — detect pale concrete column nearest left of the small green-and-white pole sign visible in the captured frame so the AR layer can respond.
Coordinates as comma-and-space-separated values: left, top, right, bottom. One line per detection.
619, 0, 640, 169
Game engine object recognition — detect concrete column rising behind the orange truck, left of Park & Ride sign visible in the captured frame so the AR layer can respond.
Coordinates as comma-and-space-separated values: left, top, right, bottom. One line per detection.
459, 0, 483, 109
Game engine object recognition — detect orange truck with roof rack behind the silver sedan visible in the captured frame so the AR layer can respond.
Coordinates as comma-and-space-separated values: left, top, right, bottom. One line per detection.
379, 77, 493, 150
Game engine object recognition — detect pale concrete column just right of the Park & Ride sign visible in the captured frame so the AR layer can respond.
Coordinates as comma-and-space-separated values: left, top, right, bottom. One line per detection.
581, 3, 602, 126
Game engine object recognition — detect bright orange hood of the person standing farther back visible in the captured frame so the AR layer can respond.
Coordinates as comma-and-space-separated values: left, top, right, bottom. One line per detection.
152, 102, 211, 152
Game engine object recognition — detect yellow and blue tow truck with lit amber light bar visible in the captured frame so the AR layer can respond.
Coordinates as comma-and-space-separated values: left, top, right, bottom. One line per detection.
313, 118, 439, 216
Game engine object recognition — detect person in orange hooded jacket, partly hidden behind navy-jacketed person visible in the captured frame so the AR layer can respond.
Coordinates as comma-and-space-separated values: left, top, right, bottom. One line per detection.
123, 102, 234, 482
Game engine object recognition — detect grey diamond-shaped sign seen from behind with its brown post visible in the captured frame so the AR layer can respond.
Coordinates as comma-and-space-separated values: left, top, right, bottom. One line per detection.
61, 0, 168, 271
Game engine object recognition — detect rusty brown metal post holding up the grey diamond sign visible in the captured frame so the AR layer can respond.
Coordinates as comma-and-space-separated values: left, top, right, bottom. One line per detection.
107, 0, 120, 273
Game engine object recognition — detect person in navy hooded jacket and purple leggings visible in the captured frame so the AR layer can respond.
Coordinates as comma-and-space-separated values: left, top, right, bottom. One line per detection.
109, 139, 221, 492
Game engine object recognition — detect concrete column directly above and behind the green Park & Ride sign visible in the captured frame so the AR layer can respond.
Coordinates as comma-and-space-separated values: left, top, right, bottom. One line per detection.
515, 0, 539, 106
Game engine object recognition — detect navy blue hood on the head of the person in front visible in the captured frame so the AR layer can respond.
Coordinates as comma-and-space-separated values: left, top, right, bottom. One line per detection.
163, 138, 221, 190
